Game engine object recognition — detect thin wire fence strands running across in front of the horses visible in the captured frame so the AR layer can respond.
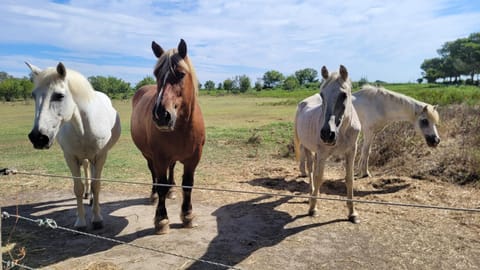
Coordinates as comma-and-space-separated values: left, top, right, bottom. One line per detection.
0, 169, 480, 269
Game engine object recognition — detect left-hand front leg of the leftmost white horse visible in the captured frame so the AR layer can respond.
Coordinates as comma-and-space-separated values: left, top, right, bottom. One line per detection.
64, 155, 87, 231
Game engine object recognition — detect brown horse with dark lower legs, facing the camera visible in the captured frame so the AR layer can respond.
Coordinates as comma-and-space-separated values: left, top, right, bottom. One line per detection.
131, 39, 205, 234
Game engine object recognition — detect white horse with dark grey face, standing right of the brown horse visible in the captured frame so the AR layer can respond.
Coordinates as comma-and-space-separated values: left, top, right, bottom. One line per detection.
294, 65, 361, 223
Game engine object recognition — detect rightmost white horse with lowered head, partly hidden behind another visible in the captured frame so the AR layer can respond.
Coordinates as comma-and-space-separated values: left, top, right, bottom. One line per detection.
353, 85, 440, 177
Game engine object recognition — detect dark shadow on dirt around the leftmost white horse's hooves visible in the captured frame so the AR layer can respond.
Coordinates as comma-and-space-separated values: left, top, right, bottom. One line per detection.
2, 194, 153, 268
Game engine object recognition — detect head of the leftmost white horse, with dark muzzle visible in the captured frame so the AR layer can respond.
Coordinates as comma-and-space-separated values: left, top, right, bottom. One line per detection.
26, 63, 75, 149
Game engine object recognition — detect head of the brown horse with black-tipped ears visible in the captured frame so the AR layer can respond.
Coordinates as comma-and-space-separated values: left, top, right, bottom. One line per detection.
152, 39, 198, 131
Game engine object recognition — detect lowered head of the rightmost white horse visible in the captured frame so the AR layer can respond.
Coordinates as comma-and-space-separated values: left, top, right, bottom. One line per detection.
415, 104, 440, 147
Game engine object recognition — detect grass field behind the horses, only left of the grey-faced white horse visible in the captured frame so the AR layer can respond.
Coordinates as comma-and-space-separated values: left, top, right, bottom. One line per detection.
0, 96, 295, 188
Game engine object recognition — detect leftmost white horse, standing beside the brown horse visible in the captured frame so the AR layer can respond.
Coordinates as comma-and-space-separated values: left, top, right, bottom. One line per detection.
26, 63, 121, 230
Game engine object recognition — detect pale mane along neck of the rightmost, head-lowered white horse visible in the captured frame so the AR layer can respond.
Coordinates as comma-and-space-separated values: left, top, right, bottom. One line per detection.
361, 84, 440, 124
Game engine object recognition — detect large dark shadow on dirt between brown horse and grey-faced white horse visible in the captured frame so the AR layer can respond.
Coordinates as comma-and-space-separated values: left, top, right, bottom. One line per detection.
187, 195, 348, 270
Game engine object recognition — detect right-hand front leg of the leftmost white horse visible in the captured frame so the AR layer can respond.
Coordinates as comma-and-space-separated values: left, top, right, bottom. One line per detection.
90, 154, 107, 230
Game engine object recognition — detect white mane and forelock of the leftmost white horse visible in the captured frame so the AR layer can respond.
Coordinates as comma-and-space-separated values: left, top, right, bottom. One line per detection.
35, 67, 95, 100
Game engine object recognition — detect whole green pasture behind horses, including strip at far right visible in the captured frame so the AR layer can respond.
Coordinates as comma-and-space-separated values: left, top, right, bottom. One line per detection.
0, 84, 480, 189
